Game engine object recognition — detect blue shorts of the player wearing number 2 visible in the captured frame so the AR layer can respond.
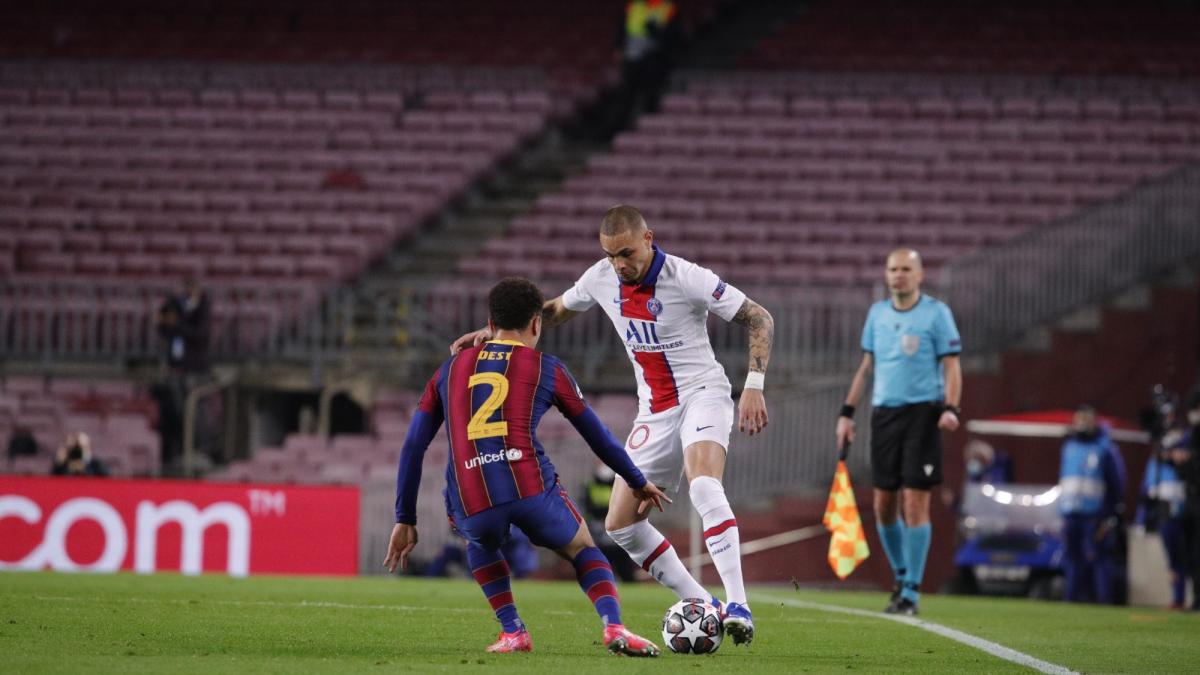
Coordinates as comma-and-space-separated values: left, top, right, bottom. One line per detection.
446, 484, 583, 551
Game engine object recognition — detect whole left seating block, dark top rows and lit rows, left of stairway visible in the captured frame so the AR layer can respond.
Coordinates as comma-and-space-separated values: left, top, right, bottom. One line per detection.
0, 0, 718, 356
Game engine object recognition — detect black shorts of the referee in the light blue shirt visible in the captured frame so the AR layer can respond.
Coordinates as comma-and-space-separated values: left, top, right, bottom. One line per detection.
871, 402, 942, 491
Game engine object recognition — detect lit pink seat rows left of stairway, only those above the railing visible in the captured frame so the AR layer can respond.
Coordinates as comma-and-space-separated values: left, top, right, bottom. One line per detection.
0, 83, 546, 280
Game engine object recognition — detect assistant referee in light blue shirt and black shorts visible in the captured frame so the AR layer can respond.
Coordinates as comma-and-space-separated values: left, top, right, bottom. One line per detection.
836, 249, 962, 616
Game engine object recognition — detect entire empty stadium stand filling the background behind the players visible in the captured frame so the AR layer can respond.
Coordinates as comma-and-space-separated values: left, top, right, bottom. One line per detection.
0, 0, 1200, 598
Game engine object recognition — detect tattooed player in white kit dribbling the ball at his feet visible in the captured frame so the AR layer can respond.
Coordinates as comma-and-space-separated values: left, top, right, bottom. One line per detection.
450, 205, 774, 644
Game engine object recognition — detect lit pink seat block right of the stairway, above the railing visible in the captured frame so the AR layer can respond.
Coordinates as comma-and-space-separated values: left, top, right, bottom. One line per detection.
460, 82, 1200, 286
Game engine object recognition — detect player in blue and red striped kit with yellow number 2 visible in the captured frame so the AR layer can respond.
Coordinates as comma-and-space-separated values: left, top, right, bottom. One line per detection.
384, 277, 670, 656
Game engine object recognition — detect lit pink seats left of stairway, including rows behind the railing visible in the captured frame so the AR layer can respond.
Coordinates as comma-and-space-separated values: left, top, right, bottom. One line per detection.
0, 74, 554, 353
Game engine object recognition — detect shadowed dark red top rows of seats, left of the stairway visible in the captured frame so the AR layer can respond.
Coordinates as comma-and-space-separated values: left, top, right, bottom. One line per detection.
0, 0, 720, 97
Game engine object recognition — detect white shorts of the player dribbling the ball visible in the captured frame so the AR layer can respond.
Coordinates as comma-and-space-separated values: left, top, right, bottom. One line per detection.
625, 389, 733, 495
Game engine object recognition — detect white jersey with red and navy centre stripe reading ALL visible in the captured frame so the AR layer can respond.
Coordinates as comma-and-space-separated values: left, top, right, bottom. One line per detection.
563, 246, 746, 414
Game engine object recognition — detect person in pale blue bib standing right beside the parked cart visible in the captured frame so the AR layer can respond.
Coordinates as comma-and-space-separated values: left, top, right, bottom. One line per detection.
1058, 406, 1124, 604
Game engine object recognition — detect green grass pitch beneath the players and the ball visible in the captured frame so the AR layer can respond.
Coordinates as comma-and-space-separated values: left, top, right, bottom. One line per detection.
0, 573, 1200, 675
